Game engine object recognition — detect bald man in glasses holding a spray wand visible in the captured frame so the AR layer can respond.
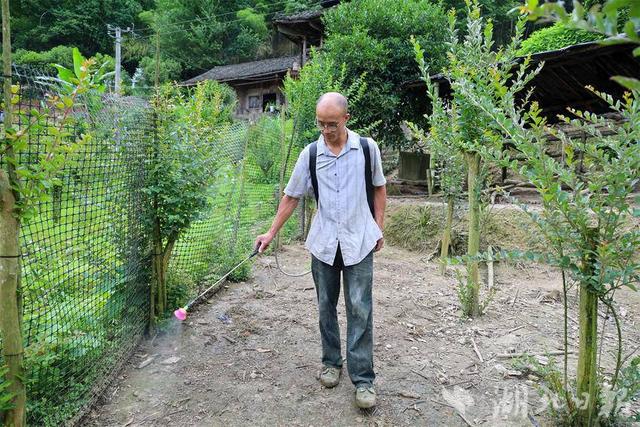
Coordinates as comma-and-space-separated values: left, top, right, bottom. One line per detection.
256, 92, 386, 408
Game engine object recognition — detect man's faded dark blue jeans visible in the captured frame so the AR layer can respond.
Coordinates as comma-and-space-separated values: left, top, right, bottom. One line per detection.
311, 246, 376, 386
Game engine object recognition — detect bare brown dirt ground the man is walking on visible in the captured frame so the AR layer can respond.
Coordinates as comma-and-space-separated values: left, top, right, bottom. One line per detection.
83, 242, 640, 426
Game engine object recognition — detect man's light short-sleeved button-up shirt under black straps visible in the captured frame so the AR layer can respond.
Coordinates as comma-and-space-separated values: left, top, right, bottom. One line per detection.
284, 129, 387, 266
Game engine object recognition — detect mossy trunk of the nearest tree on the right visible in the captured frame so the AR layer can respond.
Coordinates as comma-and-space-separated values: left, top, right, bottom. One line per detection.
577, 229, 598, 427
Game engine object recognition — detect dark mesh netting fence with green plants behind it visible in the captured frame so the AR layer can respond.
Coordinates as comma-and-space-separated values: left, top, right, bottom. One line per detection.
0, 68, 299, 425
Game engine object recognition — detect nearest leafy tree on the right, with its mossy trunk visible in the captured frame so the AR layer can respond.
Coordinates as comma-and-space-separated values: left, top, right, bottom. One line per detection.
461, 75, 640, 426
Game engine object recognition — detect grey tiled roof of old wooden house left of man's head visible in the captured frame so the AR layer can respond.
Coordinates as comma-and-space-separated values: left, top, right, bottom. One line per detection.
183, 55, 300, 86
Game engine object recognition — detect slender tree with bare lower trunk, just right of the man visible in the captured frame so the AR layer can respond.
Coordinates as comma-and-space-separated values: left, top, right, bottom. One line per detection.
414, 2, 525, 317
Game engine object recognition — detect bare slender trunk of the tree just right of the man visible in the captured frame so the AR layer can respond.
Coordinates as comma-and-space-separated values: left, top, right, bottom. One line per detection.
465, 153, 480, 317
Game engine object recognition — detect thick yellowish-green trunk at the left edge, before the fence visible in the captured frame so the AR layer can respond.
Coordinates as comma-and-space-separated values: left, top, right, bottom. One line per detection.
0, 170, 26, 427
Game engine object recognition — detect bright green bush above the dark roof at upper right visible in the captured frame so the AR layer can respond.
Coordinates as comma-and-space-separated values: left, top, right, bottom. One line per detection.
518, 23, 605, 56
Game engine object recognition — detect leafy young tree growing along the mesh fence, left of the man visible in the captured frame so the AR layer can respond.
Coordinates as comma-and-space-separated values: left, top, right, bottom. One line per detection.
142, 81, 236, 323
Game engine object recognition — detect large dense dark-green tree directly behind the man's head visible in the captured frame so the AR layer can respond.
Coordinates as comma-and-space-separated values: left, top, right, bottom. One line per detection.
323, 0, 447, 146
